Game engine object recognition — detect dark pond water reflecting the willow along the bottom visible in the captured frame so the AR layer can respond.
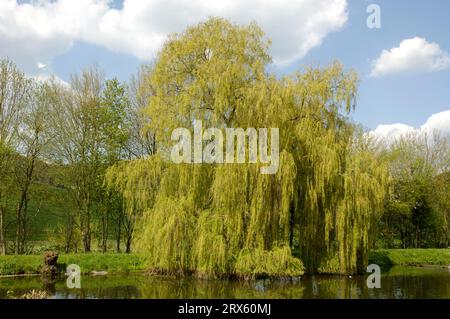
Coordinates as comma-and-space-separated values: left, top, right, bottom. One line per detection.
0, 267, 450, 299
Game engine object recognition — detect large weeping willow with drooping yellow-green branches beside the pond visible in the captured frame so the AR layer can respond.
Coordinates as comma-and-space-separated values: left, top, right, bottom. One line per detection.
107, 18, 388, 277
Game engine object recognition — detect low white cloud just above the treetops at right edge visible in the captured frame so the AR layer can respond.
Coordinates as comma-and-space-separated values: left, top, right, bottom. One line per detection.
369, 110, 450, 142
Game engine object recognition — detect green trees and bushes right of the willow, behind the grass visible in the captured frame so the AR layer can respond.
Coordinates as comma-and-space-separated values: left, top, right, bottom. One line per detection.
380, 135, 450, 248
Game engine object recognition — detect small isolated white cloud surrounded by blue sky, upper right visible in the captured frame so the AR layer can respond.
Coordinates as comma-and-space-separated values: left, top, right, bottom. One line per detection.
371, 37, 450, 76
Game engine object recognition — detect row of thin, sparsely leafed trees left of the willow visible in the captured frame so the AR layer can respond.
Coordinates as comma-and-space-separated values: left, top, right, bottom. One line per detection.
0, 59, 156, 254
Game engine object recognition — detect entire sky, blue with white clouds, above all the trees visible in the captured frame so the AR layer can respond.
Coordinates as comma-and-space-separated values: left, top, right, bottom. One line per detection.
0, 0, 450, 132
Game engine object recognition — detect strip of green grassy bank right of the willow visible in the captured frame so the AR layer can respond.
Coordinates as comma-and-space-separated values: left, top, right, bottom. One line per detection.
369, 249, 450, 267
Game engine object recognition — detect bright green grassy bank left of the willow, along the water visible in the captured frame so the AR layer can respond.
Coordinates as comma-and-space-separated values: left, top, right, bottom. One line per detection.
0, 253, 146, 276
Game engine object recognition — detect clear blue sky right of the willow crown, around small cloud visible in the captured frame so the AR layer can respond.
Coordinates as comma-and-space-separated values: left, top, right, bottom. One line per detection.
289, 0, 450, 129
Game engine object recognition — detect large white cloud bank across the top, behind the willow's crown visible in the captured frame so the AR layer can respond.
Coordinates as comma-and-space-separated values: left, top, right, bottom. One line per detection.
0, 0, 347, 77
